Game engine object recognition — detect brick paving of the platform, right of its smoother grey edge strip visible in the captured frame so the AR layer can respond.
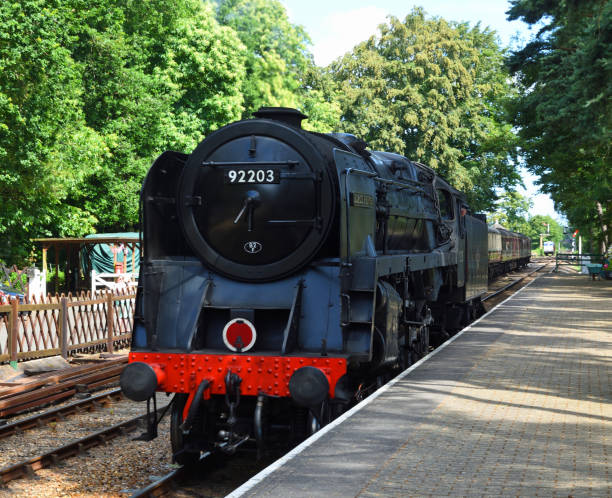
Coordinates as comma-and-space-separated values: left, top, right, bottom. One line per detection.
360, 276, 612, 496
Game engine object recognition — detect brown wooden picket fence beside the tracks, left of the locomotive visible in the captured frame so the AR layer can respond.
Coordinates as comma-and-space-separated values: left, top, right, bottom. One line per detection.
0, 291, 136, 363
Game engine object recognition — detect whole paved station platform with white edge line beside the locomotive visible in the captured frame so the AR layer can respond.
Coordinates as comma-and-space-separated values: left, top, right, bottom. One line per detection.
229, 273, 612, 497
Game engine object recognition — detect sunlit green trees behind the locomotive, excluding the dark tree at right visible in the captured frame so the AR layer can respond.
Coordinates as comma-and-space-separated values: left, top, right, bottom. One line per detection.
0, 0, 536, 262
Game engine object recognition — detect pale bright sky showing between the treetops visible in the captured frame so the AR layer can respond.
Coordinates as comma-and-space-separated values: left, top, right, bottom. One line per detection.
280, 0, 563, 221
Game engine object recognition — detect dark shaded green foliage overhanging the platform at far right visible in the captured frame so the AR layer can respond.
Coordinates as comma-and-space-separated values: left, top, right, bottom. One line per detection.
508, 0, 612, 250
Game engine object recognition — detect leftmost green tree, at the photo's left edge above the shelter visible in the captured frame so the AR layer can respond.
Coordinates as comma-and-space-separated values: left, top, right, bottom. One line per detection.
0, 0, 105, 259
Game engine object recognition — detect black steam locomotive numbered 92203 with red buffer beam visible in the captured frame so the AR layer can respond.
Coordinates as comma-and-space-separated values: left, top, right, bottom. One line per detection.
121, 108, 528, 462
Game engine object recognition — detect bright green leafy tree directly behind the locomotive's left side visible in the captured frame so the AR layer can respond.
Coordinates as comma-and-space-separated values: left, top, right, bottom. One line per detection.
67, 0, 244, 231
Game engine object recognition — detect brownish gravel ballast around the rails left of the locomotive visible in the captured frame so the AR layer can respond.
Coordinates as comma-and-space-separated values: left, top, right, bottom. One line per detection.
0, 394, 174, 497
